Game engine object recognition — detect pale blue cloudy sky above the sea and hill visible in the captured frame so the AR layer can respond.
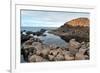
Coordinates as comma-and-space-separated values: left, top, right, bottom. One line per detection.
21, 10, 89, 27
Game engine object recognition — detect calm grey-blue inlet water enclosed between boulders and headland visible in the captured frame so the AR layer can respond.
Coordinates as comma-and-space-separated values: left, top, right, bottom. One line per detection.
39, 31, 67, 47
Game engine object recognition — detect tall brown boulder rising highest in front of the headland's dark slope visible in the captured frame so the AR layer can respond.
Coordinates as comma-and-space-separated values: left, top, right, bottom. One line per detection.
68, 39, 81, 55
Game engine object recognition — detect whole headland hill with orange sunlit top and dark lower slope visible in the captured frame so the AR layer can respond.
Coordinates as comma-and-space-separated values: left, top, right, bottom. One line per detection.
54, 18, 89, 42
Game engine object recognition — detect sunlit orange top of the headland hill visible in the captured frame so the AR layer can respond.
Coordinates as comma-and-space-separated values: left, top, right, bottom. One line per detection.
64, 18, 89, 27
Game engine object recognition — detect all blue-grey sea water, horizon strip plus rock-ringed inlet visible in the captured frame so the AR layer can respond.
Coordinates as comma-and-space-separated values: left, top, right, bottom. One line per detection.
21, 27, 68, 47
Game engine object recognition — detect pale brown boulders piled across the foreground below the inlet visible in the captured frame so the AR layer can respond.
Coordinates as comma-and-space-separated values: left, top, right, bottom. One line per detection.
21, 30, 90, 63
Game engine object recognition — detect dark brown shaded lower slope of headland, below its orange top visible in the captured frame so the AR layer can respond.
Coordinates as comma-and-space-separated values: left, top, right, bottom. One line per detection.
49, 25, 90, 42
